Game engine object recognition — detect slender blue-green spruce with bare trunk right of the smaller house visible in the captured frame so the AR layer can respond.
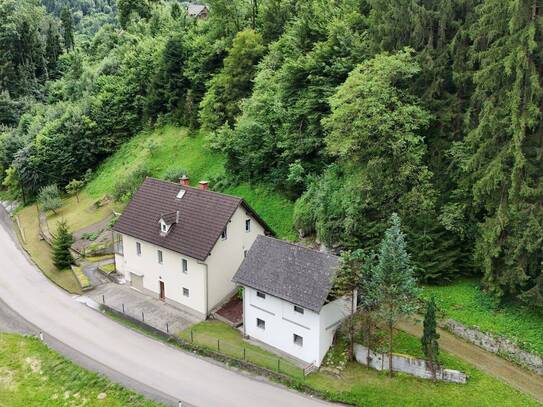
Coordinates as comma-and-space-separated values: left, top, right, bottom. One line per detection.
375, 213, 418, 377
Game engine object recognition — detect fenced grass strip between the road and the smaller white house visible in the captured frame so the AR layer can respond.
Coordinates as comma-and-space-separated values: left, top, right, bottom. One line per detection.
179, 321, 303, 378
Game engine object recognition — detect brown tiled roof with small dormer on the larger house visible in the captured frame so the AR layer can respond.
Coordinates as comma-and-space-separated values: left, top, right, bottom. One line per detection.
113, 178, 273, 261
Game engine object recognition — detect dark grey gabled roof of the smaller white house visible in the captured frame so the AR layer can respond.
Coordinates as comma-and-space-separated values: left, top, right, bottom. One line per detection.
232, 236, 339, 312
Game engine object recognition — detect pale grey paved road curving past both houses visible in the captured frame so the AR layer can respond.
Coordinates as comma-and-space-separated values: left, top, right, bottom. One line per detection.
0, 212, 329, 407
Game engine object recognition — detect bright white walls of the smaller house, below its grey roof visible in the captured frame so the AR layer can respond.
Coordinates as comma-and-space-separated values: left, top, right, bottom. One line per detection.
243, 287, 346, 366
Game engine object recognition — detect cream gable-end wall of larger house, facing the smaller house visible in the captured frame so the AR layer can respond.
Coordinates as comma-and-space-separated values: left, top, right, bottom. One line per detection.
206, 206, 264, 311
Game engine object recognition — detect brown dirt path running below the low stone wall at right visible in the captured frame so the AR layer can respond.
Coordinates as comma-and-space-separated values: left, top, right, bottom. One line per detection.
398, 320, 543, 403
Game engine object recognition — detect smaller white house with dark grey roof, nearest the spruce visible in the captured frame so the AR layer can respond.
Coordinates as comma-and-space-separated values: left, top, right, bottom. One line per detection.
233, 236, 350, 366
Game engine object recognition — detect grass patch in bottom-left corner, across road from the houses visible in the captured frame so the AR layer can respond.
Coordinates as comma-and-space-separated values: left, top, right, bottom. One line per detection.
0, 334, 163, 407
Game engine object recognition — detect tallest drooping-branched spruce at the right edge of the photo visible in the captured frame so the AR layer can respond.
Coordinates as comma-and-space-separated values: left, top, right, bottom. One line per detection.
453, 0, 543, 306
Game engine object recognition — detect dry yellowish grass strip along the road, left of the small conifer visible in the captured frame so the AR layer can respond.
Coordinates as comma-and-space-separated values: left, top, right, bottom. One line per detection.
17, 205, 81, 294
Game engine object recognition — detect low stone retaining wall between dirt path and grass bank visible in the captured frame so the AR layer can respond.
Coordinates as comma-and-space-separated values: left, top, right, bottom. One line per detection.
442, 319, 543, 376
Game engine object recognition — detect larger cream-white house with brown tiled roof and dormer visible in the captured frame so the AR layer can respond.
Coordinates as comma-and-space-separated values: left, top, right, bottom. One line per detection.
113, 177, 272, 319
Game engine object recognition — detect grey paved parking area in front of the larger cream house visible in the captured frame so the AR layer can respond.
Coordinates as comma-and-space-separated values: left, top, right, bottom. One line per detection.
86, 283, 200, 334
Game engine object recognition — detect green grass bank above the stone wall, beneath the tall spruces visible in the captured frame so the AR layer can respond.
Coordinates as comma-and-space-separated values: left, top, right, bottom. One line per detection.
424, 279, 543, 355
